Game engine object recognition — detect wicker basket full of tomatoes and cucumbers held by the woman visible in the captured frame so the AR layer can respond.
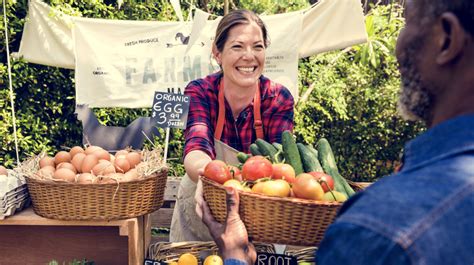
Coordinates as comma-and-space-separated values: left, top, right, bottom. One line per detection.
202, 132, 370, 246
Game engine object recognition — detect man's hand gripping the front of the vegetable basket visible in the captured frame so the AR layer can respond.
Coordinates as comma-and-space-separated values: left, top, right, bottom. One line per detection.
196, 180, 257, 265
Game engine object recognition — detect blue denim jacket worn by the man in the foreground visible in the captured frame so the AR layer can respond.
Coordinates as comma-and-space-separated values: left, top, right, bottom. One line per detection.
225, 115, 474, 265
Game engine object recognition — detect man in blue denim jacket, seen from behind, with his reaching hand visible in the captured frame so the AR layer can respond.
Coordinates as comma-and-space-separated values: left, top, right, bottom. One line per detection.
200, 0, 474, 265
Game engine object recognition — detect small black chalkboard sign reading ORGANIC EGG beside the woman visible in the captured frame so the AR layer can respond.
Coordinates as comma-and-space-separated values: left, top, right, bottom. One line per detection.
151, 92, 189, 129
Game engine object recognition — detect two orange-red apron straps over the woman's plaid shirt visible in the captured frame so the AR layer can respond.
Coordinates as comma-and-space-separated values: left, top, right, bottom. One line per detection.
214, 80, 264, 140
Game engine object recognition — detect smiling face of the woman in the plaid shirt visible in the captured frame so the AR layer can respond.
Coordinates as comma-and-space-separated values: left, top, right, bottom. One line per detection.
214, 22, 265, 88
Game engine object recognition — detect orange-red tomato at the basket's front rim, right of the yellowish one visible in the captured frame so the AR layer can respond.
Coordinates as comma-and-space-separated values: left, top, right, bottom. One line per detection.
293, 173, 324, 200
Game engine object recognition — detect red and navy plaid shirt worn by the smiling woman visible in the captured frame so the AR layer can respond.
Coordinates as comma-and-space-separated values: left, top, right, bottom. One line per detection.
184, 72, 294, 159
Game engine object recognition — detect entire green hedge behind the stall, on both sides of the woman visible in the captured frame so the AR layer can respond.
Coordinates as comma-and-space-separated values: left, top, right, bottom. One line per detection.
0, 0, 423, 181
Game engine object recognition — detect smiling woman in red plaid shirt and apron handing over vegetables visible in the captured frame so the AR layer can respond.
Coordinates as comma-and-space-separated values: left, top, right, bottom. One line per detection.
170, 10, 294, 241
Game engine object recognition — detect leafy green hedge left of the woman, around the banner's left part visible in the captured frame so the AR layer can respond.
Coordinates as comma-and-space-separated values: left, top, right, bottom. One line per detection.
0, 0, 184, 169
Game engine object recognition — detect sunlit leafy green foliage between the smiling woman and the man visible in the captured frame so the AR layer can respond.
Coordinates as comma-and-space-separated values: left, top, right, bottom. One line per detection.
295, 4, 423, 181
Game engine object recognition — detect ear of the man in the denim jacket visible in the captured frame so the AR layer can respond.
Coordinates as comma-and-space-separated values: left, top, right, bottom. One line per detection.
436, 12, 467, 65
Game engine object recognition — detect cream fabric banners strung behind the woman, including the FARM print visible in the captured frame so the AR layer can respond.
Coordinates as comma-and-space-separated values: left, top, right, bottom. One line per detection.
19, 0, 367, 108
